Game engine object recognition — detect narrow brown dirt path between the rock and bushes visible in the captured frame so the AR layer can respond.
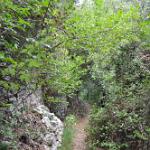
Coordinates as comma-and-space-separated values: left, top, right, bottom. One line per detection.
73, 117, 88, 150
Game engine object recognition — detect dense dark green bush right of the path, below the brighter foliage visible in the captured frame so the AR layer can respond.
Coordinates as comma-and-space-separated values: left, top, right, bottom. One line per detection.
89, 35, 150, 150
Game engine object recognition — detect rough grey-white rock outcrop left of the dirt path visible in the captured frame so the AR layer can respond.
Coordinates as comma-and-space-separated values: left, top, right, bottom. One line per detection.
8, 90, 63, 150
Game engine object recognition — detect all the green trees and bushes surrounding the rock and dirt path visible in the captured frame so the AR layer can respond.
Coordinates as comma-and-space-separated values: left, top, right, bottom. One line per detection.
0, 0, 150, 150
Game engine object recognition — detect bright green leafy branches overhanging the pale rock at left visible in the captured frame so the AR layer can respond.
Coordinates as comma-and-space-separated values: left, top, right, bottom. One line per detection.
0, 0, 85, 99
